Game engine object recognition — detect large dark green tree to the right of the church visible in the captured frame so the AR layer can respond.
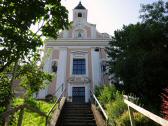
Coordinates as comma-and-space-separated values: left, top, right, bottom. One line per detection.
107, 1, 168, 110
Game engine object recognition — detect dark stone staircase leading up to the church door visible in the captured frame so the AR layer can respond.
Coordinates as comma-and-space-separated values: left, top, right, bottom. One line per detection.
59, 102, 96, 126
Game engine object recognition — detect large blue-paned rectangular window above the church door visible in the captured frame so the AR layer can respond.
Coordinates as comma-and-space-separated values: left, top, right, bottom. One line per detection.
72, 58, 86, 75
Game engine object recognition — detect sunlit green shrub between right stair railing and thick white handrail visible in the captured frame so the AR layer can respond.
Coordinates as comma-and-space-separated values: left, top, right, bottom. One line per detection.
96, 85, 127, 119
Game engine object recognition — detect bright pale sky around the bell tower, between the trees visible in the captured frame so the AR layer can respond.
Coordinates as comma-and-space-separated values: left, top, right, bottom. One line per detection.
62, 0, 166, 35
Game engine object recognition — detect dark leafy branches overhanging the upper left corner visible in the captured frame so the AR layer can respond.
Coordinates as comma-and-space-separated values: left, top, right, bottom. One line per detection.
0, 0, 69, 72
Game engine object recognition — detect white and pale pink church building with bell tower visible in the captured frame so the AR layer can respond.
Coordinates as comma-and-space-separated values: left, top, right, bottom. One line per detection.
37, 2, 110, 102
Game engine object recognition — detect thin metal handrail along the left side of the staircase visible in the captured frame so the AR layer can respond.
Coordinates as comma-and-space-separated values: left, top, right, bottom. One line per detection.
46, 84, 66, 126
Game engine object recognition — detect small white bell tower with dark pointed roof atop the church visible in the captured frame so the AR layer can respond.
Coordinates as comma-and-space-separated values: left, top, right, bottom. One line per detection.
73, 2, 87, 24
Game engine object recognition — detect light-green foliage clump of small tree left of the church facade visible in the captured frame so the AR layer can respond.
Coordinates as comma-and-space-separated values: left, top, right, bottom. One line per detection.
17, 55, 52, 98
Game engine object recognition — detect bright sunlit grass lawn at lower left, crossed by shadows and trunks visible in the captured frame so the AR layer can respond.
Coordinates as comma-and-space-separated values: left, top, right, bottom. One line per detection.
12, 99, 54, 126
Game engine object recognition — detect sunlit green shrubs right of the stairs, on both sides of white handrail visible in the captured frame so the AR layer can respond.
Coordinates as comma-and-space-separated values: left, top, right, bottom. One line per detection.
95, 85, 159, 126
